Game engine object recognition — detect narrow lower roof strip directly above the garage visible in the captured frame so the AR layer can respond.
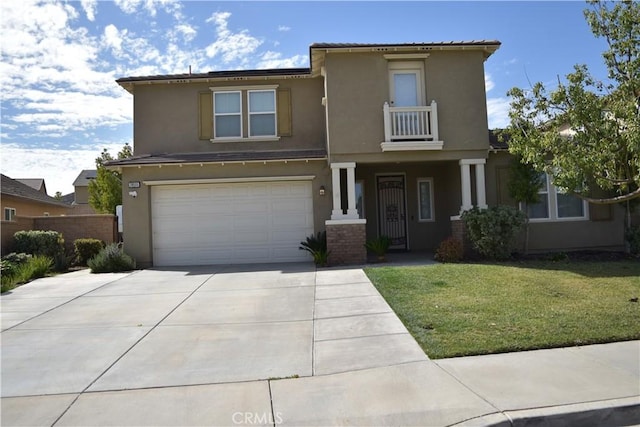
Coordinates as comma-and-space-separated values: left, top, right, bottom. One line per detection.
106, 150, 327, 166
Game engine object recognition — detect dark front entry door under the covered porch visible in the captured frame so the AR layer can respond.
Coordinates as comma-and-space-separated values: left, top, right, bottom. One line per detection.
378, 175, 407, 249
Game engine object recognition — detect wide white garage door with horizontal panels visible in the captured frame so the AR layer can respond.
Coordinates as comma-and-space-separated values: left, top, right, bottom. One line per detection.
151, 181, 313, 266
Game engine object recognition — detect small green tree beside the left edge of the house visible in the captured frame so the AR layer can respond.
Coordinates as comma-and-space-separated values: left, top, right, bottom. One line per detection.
89, 144, 133, 214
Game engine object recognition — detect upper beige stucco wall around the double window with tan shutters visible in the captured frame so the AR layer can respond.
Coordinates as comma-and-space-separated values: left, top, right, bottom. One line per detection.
133, 78, 325, 155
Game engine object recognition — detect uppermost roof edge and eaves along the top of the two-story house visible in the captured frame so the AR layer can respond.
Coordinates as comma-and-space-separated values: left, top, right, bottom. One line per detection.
116, 40, 501, 93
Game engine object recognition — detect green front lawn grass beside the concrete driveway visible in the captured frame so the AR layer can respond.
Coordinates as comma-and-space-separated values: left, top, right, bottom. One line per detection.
365, 260, 640, 359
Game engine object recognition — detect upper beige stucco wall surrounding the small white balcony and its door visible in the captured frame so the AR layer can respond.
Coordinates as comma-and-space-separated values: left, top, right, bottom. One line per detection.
325, 51, 489, 162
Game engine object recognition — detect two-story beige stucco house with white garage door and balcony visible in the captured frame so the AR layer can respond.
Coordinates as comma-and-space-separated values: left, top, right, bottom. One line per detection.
110, 41, 622, 266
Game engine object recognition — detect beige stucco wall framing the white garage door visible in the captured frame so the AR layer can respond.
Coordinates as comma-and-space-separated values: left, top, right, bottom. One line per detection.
122, 161, 332, 267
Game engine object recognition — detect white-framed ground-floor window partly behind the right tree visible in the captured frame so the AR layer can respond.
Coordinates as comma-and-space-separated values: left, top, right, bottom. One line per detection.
520, 173, 588, 222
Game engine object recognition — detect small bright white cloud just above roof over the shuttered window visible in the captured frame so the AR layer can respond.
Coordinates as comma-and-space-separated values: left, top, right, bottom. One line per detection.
205, 12, 262, 65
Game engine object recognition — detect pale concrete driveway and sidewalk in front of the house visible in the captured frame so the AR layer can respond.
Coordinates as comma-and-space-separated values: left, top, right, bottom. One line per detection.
1, 264, 640, 426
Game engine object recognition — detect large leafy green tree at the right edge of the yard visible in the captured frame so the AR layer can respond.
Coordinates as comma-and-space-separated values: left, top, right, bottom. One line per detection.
508, 0, 640, 204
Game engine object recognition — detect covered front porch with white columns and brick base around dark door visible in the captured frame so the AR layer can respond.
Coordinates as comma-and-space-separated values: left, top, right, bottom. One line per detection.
326, 159, 487, 263
